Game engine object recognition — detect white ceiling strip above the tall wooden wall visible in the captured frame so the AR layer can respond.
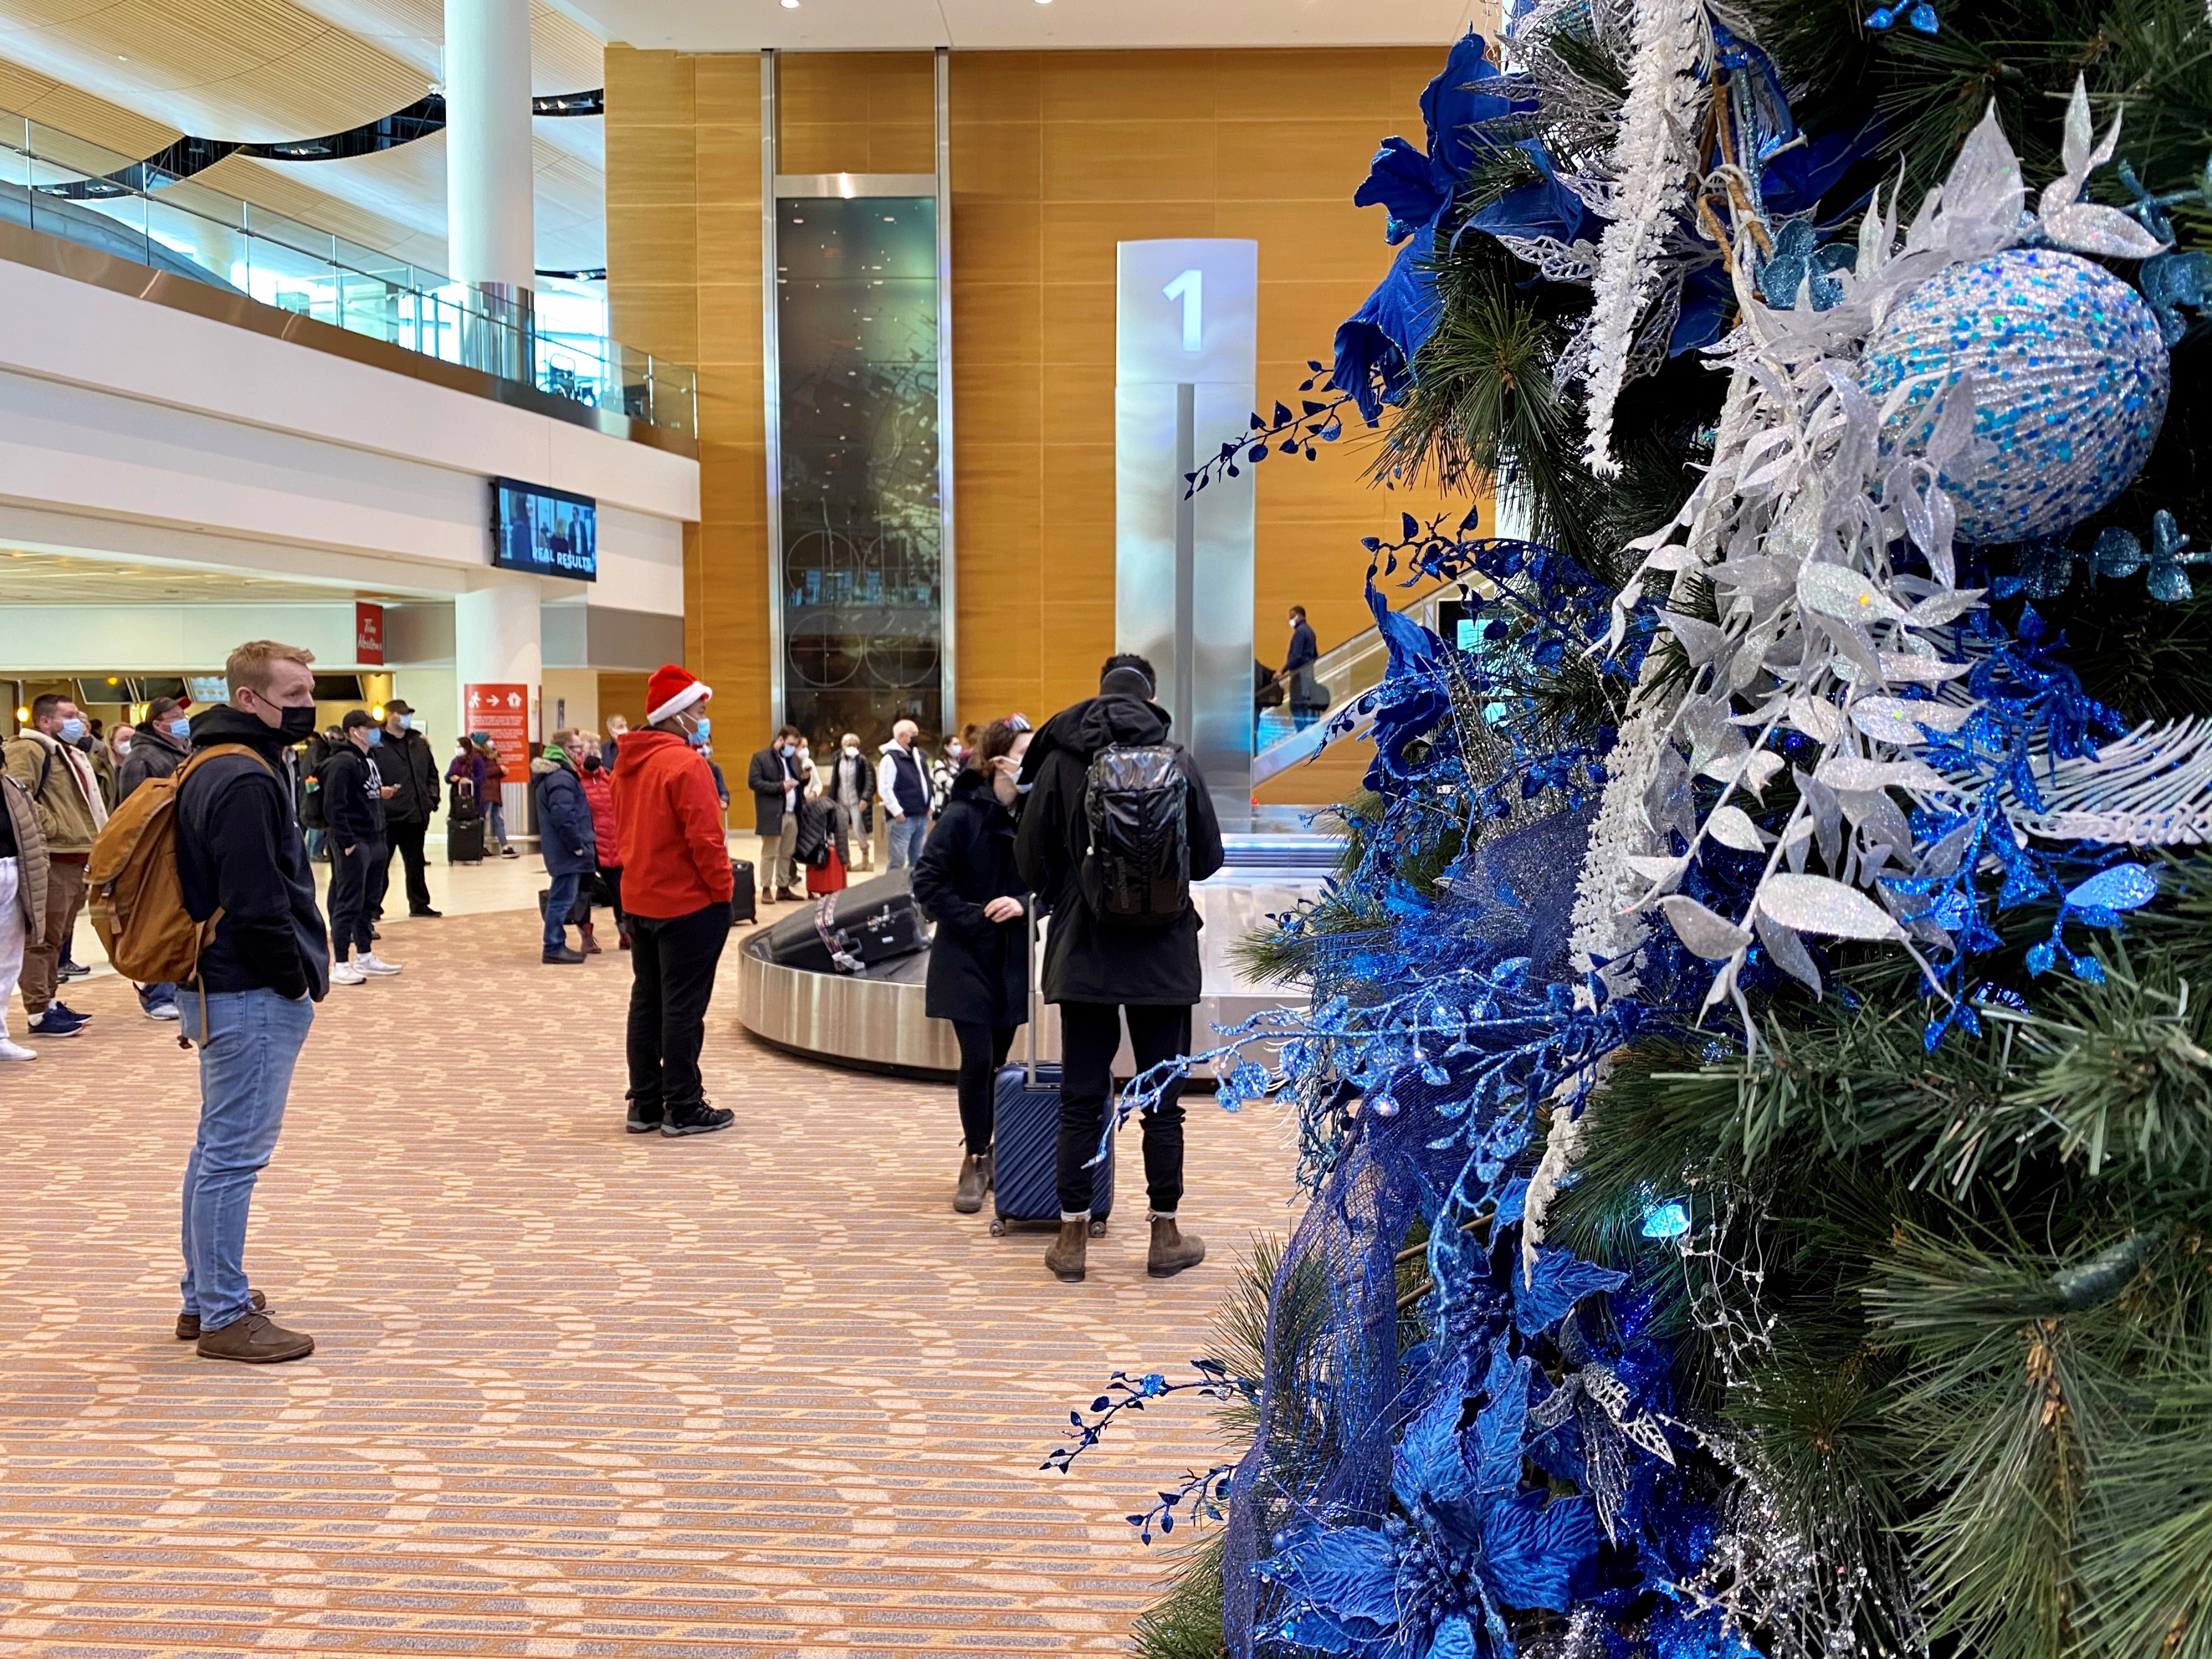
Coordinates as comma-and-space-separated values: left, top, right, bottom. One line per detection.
553, 0, 1496, 51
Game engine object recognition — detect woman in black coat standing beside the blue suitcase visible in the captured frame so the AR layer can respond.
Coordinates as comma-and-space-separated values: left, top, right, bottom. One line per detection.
914, 715, 1029, 1214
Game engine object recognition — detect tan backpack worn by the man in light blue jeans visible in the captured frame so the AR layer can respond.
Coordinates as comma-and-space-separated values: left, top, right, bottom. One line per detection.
84, 743, 270, 984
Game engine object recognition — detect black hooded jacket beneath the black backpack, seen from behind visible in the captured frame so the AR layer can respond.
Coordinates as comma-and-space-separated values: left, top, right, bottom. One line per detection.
1015, 697, 1221, 1006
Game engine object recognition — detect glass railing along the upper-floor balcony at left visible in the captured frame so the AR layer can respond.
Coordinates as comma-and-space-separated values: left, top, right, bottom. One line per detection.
0, 111, 699, 438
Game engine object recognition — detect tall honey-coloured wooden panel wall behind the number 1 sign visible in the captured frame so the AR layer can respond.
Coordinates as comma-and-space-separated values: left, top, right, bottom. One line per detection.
606, 42, 1464, 799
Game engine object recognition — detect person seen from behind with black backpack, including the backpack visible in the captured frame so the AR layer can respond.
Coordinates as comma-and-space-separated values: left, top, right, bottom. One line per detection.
1015, 655, 1223, 1281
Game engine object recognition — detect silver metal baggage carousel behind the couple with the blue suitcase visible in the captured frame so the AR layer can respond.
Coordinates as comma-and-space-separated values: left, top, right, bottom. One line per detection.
737, 834, 1343, 1077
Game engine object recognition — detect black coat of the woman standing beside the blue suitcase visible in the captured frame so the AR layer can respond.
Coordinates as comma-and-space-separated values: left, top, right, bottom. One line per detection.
914, 767, 1029, 1031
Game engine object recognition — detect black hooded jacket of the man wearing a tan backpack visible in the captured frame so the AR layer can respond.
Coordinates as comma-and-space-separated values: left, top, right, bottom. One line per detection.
177, 704, 329, 1002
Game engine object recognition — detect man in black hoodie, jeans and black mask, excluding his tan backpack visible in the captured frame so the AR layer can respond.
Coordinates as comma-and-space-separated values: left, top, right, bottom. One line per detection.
177, 639, 329, 1365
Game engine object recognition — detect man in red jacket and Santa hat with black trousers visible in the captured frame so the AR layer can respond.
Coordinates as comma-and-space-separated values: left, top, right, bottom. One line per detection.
615, 664, 737, 1135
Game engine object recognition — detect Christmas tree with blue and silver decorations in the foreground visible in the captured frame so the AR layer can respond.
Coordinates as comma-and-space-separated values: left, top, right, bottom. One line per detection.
1044, 0, 2212, 1659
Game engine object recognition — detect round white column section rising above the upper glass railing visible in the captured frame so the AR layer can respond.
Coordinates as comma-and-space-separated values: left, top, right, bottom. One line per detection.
445, 0, 538, 345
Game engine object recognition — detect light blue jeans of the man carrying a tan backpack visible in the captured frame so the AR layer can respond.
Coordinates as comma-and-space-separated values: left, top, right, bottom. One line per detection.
177, 991, 314, 1332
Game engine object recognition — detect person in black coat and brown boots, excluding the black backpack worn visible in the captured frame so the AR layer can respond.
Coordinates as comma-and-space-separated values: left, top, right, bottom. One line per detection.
1015, 655, 1221, 1281
